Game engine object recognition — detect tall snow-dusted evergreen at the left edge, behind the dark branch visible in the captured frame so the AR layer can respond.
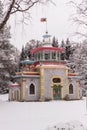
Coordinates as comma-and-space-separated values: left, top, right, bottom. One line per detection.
0, 1, 18, 92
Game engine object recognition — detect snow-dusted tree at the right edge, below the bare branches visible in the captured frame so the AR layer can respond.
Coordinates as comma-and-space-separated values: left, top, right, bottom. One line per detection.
73, 40, 87, 87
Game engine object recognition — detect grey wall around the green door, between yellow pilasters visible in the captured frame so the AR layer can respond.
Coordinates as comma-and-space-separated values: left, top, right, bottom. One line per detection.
44, 68, 66, 99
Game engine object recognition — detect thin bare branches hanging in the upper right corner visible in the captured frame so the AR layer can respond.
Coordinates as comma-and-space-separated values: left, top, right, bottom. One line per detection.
70, 0, 87, 38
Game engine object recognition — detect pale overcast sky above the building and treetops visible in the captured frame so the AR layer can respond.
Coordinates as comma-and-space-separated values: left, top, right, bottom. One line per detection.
9, 0, 79, 50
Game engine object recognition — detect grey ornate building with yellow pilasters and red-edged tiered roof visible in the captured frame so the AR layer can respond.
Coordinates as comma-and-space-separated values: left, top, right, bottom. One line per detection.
9, 34, 82, 101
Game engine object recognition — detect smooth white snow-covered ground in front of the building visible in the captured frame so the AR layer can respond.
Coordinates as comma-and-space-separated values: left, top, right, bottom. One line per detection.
0, 95, 87, 130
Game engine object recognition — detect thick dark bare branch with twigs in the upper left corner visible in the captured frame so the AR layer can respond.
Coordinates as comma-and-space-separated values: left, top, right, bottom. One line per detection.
0, 0, 53, 30
